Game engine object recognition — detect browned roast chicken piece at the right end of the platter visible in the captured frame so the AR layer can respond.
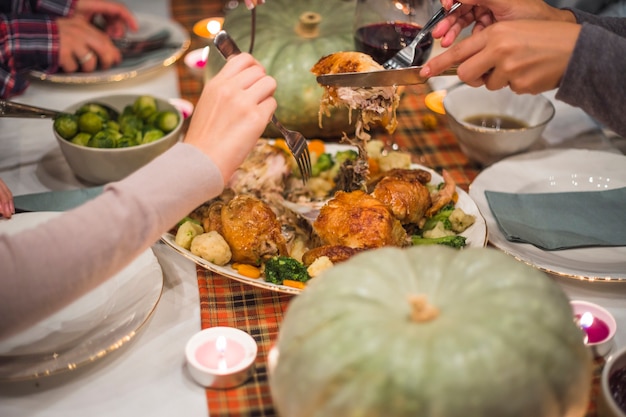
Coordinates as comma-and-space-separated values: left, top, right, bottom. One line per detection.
372, 177, 431, 224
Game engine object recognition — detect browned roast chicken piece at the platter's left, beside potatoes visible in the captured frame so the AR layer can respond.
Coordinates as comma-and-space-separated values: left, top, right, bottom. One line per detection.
221, 194, 287, 265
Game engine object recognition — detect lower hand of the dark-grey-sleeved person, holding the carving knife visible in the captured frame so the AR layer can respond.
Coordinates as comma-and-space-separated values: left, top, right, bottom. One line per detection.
420, 20, 580, 94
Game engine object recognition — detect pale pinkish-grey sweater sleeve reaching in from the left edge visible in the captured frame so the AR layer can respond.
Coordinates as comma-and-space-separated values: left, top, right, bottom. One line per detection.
0, 143, 224, 339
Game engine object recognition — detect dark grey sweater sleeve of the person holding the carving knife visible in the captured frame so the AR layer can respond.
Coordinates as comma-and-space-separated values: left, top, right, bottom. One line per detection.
556, 11, 626, 136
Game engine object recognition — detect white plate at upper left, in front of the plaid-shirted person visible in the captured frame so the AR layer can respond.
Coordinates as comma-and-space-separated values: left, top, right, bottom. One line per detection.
31, 13, 191, 84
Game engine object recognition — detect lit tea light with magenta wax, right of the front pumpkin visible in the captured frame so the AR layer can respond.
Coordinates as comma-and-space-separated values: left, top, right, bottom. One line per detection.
570, 300, 617, 357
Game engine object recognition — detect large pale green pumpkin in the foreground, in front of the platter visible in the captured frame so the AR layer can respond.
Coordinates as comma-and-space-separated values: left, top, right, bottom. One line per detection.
270, 246, 591, 417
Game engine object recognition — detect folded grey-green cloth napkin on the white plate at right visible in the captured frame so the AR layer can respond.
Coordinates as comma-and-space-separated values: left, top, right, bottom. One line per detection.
485, 187, 626, 250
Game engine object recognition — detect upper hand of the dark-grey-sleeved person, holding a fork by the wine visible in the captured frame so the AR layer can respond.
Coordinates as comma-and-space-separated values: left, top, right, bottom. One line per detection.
432, 0, 575, 48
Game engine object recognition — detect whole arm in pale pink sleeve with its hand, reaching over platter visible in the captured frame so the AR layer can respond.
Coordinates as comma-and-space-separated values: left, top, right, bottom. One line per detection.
0, 53, 276, 339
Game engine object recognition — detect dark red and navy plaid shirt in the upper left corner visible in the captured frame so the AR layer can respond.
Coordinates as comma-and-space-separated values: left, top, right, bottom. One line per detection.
0, 0, 77, 98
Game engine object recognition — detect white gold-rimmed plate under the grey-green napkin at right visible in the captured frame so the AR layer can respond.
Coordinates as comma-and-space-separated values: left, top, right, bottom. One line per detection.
469, 149, 626, 282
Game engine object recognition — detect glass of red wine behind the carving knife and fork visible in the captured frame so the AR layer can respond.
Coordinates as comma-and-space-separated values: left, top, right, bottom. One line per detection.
354, 0, 434, 65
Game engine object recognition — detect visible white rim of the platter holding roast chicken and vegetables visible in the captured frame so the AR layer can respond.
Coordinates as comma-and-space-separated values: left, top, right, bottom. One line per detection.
161, 144, 487, 294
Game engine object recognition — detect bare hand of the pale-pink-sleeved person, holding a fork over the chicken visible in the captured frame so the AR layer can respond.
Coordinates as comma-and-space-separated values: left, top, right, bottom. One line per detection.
185, 53, 276, 181
